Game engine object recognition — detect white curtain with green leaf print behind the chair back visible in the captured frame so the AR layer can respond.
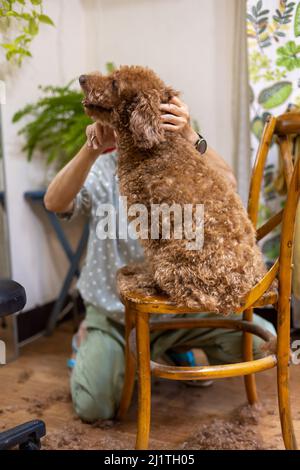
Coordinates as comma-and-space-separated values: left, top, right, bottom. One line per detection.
247, 0, 300, 324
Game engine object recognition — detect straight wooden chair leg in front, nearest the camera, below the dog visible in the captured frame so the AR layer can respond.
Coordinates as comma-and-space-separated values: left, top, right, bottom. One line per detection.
136, 312, 151, 450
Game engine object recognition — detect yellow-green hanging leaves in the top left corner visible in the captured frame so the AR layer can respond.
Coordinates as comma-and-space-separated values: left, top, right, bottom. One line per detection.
0, 0, 54, 65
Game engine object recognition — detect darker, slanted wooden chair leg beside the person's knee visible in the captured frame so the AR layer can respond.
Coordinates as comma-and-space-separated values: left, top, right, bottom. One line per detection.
117, 305, 136, 420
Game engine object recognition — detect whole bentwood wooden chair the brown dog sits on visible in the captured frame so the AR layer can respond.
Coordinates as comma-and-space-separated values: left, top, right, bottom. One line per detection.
118, 113, 300, 449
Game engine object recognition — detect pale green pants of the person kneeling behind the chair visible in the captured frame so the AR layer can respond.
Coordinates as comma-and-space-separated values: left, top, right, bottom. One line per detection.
71, 306, 276, 422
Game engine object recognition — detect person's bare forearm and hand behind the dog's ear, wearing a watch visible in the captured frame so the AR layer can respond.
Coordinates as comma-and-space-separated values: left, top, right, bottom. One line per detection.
160, 97, 237, 189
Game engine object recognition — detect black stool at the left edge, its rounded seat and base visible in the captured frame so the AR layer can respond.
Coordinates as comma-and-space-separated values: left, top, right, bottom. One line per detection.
0, 279, 46, 450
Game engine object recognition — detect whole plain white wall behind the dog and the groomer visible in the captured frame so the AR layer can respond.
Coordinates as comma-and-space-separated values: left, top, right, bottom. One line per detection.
4, 0, 241, 308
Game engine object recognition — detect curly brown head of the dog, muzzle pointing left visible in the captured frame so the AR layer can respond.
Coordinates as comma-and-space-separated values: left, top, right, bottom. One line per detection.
79, 66, 178, 149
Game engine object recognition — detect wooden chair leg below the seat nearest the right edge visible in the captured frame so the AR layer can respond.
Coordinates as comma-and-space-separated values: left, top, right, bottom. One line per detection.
277, 302, 297, 450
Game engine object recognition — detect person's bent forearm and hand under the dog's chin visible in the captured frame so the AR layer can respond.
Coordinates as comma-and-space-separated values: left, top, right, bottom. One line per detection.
44, 123, 115, 213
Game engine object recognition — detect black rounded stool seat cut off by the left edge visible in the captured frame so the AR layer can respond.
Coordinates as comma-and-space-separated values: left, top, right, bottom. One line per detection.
0, 279, 26, 317
